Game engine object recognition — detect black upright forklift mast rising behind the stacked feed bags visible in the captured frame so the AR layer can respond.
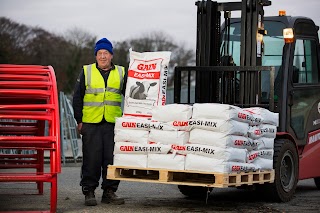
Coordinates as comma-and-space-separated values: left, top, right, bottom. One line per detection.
195, 0, 271, 104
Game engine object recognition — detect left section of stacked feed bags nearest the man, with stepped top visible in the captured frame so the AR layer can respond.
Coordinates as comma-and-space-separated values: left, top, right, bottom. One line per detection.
114, 104, 192, 170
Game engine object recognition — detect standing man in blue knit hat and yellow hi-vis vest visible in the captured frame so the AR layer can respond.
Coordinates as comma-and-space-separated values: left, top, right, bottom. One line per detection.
73, 38, 127, 206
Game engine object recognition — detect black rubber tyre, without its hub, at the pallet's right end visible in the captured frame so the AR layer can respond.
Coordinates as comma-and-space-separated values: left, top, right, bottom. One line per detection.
257, 139, 299, 202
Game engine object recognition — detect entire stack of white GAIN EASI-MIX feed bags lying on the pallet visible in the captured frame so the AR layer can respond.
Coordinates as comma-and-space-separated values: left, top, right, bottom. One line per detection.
114, 103, 278, 173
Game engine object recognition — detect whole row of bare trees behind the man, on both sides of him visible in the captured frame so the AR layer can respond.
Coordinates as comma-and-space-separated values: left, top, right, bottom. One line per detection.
0, 17, 195, 93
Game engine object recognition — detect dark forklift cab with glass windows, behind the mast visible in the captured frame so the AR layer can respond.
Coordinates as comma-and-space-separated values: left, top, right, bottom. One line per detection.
220, 16, 320, 145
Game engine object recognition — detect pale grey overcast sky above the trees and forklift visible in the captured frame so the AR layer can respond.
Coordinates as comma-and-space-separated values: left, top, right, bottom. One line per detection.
0, 0, 320, 48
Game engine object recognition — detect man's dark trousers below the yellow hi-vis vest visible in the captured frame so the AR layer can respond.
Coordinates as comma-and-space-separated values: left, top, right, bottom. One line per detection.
80, 122, 120, 194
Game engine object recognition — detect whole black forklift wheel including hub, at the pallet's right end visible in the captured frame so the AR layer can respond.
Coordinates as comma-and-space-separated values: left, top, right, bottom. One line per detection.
257, 139, 299, 202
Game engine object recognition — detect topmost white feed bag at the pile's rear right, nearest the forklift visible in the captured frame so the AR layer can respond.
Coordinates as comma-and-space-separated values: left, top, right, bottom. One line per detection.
244, 107, 279, 126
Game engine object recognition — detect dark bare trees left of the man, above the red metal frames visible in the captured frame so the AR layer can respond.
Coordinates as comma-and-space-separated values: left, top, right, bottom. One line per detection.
0, 17, 95, 93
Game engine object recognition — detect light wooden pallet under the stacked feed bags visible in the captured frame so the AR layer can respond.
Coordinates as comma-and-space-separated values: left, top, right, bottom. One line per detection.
107, 165, 274, 188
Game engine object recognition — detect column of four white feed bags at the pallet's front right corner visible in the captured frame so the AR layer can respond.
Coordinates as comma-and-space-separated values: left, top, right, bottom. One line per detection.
185, 103, 256, 173
